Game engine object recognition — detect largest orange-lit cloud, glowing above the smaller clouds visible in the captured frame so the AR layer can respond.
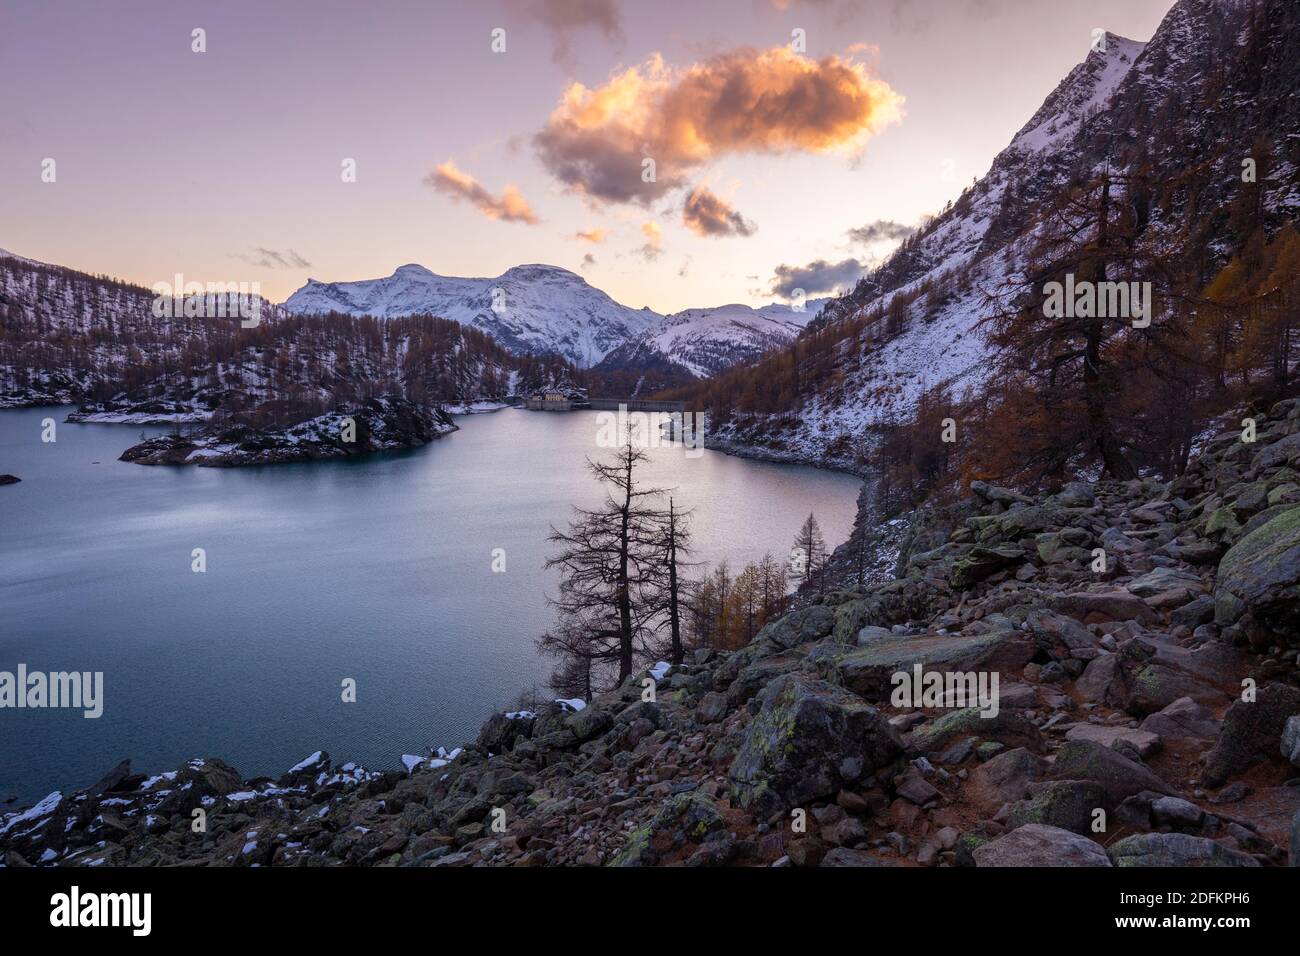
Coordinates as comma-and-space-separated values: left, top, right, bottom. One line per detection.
534, 47, 902, 203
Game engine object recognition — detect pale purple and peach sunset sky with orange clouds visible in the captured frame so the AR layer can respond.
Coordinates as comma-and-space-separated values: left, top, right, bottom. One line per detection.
0, 0, 1173, 312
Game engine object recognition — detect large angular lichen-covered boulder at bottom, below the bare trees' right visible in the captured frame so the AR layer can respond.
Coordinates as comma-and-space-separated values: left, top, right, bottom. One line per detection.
728, 674, 902, 817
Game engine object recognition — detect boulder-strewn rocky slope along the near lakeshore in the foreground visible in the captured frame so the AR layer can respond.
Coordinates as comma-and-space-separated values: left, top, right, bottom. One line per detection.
0, 401, 1300, 866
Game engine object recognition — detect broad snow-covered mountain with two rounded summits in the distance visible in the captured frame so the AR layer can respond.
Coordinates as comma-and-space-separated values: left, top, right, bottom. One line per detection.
285, 264, 662, 367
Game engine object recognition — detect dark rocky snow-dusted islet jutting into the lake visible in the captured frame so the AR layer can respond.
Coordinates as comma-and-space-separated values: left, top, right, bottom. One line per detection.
121, 398, 456, 468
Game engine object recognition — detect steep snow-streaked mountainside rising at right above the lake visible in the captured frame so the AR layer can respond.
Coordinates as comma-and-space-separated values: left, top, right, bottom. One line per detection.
698, 0, 1300, 468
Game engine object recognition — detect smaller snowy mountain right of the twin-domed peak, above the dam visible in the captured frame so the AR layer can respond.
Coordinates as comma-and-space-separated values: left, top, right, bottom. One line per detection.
597, 299, 829, 378
